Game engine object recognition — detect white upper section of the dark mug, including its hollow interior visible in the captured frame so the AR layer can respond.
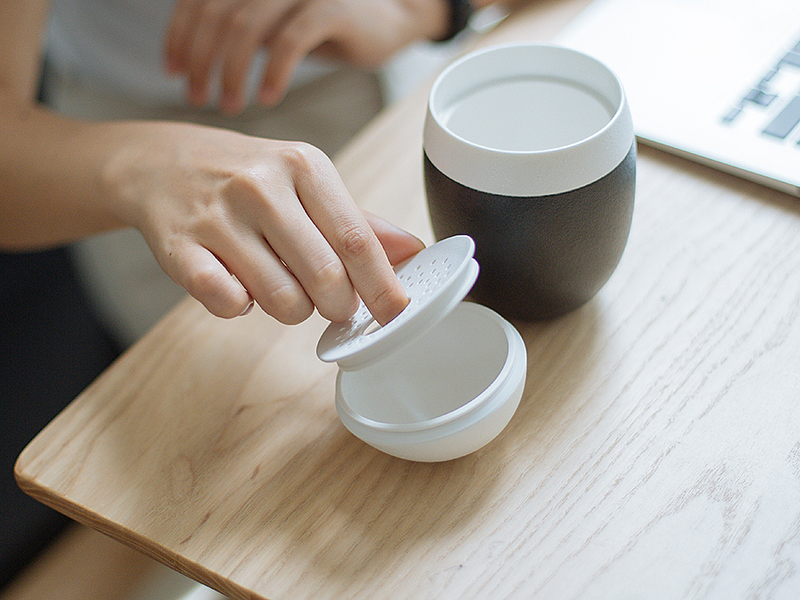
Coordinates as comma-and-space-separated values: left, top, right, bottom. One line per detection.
423, 44, 635, 197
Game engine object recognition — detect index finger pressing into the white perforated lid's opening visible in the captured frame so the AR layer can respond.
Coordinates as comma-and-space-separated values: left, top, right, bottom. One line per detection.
295, 146, 409, 325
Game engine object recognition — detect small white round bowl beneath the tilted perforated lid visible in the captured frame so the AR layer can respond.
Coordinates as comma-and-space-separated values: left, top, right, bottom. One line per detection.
336, 302, 527, 462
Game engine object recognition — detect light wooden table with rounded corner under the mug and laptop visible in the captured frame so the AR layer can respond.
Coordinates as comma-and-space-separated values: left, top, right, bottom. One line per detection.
17, 0, 800, 600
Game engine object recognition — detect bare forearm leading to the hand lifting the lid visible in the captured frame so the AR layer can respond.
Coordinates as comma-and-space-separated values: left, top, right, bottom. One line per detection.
0, 92, 133, 250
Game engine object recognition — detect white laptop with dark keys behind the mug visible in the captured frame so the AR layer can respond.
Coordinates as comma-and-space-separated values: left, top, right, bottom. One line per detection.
554, 0, 800, 196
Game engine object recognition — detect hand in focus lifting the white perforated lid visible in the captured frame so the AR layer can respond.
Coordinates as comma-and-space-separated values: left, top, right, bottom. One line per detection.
104, 123, 423, 325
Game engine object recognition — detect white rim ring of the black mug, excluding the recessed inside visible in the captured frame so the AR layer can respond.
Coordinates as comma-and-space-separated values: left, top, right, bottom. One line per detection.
423, 44, 634, 197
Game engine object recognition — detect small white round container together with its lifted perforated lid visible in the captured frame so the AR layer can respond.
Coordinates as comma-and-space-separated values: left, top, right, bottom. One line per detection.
317, 236, 527, 462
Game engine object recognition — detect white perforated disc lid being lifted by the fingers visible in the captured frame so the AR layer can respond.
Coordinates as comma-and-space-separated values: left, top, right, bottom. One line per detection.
317, 235, 478, 371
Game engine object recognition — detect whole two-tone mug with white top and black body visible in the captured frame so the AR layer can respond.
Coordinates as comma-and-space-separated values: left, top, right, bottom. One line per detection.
423, 44, 636, 320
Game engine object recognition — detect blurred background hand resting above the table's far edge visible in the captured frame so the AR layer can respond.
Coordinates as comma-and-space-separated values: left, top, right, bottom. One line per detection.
166, 0, 449, 113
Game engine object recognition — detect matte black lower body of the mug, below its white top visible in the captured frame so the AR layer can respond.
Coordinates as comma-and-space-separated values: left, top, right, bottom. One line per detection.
424, 142, 636, 320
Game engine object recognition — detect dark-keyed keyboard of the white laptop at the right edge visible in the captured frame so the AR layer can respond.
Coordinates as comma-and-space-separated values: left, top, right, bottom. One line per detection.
722, 40, 800, 148
